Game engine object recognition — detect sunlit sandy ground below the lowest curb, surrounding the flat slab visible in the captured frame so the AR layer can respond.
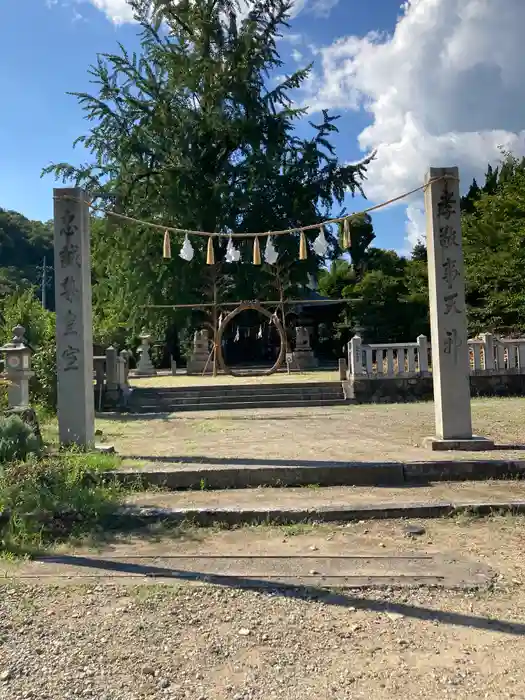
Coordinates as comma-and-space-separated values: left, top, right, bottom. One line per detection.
0, 517, 525, 700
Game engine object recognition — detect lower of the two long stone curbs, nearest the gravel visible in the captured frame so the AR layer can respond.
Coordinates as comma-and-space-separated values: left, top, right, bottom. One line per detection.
114, 501, 525, 526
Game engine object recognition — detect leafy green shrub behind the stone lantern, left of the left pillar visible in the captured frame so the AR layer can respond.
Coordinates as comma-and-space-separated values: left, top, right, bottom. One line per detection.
0, 289, 57, 409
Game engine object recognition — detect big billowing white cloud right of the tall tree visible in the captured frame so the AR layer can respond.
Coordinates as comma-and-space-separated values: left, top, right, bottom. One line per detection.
307, 0, 525, 250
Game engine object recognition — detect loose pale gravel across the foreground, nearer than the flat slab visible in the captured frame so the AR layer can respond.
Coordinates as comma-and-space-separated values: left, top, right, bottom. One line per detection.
0, 586, 525, 700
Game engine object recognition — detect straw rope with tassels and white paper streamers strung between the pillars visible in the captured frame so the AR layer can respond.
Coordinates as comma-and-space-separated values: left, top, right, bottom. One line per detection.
55, 175, 457, 265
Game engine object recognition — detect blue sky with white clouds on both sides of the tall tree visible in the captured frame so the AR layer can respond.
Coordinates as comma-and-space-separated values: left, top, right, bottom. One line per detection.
4, 0, 525, 250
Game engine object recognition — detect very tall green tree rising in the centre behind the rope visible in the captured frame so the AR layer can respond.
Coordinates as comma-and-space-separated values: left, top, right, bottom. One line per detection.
47, 0, 366, 344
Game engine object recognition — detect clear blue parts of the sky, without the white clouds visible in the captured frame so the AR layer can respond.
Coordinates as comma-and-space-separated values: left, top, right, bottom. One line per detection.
0, 0, 404, 252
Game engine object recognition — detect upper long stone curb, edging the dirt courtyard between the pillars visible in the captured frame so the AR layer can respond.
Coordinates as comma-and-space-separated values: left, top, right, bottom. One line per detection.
103, 460, 525, 490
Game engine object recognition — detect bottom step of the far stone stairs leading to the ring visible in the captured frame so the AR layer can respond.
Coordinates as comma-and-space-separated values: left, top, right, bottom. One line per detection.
128, 396, 347, 414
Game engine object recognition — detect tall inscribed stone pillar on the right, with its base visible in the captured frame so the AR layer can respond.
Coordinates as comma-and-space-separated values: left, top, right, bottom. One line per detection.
425, 168, 489, 450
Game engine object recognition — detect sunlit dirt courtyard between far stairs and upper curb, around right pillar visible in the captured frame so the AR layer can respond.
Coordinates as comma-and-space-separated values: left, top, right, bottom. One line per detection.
93, 398, 525, 466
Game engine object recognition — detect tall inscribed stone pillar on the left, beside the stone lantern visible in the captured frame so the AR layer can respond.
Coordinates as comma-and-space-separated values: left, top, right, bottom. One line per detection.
54, 187, 95, 447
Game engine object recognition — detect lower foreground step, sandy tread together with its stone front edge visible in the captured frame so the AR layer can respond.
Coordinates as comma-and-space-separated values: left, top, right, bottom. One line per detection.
117, 481, 525, 525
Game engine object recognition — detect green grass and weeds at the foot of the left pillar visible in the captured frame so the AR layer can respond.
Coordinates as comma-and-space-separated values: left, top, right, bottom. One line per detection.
0, 454, 123, 550
